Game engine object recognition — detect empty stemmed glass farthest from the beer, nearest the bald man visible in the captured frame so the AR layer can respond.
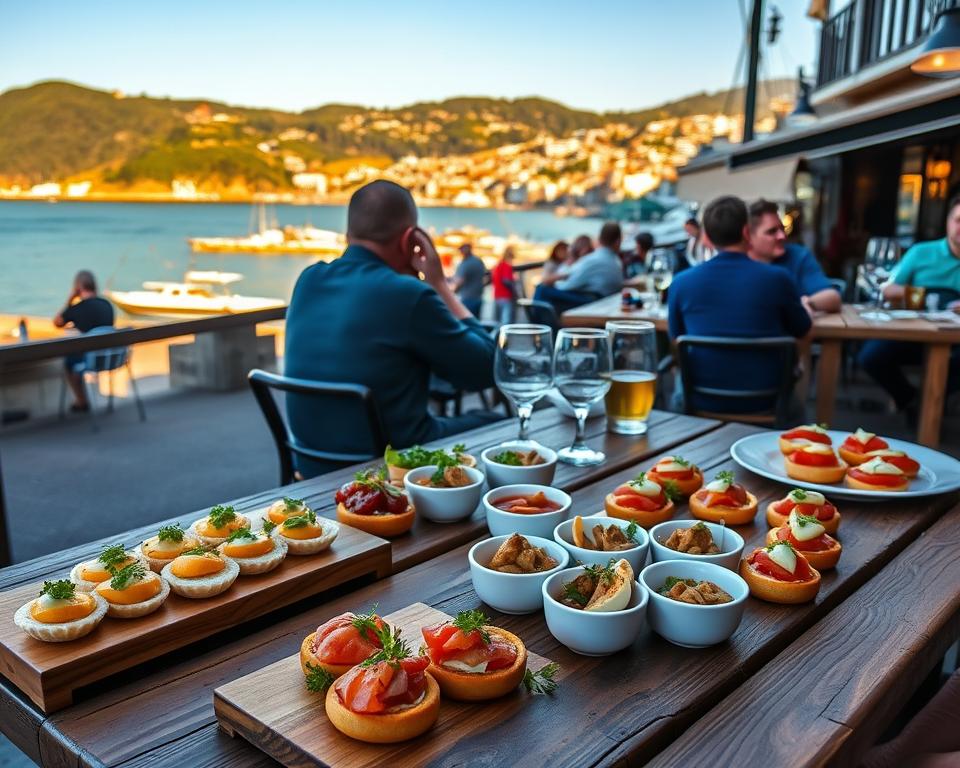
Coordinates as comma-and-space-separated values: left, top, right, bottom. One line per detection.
493, 323, 553, 445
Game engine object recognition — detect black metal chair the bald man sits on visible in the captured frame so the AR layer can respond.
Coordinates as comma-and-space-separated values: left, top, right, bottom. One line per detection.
247, 368, 387, 485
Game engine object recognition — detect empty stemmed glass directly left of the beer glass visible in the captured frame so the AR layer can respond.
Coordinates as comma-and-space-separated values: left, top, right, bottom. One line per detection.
553, 328, 612, 467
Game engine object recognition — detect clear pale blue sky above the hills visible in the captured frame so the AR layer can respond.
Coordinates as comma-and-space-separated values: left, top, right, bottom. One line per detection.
0, 0, 819, 111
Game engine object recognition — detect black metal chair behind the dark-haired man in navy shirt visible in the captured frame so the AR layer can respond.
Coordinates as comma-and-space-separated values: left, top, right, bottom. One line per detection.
676, 336, 797, 426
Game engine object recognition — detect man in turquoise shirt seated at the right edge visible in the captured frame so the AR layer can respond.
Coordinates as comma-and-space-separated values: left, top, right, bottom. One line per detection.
857, 195, 960, 414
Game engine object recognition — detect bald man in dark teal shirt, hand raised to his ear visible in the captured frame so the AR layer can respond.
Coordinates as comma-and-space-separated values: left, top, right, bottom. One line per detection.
284, 181, 502, 477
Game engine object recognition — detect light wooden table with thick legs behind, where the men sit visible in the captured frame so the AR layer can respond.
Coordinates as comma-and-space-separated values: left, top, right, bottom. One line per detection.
562, 294, 960, 448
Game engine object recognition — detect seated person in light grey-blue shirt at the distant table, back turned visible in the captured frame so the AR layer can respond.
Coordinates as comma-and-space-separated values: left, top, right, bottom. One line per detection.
533, 221, 623, 314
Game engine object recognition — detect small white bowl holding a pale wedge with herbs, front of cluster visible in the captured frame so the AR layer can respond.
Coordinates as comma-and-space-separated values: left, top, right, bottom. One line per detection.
543, 568, 649, 656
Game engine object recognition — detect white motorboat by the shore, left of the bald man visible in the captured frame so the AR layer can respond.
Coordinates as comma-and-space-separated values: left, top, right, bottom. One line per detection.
106, 270, 286, 317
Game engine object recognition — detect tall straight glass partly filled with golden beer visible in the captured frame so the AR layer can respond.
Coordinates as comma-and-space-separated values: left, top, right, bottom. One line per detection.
606, 320, 657, 435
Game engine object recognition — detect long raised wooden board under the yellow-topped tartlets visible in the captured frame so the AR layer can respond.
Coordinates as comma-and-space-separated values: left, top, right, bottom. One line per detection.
0, 524, 392, 713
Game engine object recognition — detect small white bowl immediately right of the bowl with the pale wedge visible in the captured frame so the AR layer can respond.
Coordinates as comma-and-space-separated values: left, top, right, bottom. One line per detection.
640, 560, 750, 648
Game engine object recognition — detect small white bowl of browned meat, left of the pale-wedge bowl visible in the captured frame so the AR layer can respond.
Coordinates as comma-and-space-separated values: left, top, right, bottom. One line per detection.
467, 536, 570, 614
